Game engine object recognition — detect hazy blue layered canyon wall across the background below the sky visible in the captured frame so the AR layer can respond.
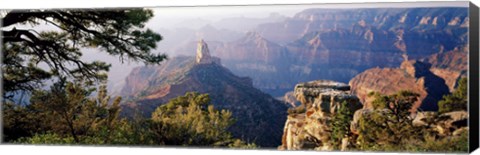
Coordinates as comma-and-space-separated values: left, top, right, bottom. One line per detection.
156, 8, 468, 97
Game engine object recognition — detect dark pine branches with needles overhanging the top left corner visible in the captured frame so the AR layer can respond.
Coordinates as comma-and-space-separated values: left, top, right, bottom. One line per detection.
0, 9, 166, 98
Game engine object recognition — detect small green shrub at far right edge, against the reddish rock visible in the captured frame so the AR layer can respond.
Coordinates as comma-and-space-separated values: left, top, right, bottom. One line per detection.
438, 78, 468, 113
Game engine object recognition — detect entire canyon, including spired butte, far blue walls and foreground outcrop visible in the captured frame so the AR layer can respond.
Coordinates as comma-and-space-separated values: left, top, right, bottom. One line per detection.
114, 7, 469, 150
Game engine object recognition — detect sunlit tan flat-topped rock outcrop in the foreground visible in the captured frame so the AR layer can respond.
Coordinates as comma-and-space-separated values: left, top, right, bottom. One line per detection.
279, 80, 362, 150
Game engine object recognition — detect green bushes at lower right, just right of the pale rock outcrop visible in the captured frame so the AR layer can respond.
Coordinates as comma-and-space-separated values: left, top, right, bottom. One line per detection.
356, 90, 468, 152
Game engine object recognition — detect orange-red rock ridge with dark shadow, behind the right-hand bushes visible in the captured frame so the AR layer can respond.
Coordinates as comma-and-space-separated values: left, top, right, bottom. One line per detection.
349, 43, 468, 111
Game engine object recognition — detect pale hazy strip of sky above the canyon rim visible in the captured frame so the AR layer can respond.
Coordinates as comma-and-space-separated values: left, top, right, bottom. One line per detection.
148, 1, 468, 27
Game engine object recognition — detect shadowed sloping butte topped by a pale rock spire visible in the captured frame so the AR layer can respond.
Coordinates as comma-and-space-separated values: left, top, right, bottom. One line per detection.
123, 42, 287, 147
